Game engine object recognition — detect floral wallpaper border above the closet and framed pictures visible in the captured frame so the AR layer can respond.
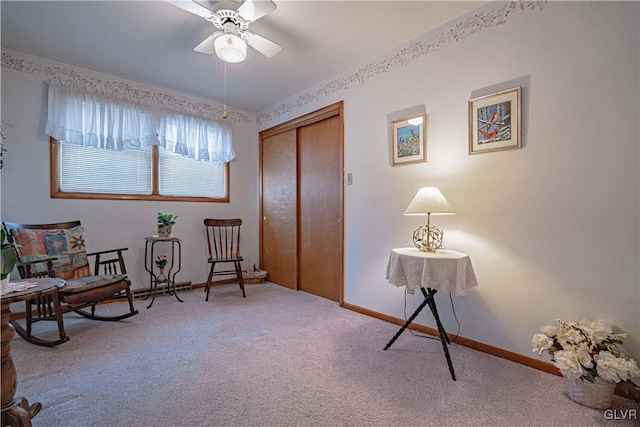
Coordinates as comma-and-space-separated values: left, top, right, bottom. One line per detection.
257, 0, 548, 125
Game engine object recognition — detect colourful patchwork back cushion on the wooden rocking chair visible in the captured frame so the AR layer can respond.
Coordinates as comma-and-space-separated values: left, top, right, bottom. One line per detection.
11, 226, 92, 280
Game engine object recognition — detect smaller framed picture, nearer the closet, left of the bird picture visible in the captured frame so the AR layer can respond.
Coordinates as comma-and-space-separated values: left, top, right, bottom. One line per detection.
391, 113, 427, 166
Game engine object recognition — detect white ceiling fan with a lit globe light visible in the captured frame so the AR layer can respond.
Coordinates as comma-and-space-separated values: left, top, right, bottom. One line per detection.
165, 0, 282, 63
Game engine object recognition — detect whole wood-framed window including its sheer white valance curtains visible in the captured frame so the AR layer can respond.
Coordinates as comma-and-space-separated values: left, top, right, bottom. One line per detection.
45, 81, 235, 202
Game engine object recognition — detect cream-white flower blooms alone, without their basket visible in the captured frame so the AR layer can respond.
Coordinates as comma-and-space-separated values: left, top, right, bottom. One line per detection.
531, 319, 640, 389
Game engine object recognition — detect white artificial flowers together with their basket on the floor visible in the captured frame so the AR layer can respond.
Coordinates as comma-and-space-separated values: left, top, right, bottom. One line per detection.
531, 319, 640, 409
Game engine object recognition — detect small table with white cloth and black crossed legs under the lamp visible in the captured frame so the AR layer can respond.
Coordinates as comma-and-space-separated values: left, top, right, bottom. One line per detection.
384, 248, 478, 381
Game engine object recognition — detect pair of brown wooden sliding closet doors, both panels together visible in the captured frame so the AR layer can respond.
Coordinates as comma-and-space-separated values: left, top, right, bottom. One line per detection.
260, 103, 344, 303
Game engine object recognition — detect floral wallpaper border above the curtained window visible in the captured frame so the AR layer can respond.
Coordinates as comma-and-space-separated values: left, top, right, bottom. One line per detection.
2, 52, 253, 123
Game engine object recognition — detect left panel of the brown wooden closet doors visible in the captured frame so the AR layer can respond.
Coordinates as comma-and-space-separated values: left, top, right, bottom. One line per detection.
260, 129, 298, 289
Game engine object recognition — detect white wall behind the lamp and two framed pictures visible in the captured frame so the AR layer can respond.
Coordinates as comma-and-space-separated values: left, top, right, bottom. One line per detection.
258, 2, 640, 360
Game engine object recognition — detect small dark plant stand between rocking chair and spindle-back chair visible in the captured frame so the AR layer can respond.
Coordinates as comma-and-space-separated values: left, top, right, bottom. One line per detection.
144, 234, 184, 308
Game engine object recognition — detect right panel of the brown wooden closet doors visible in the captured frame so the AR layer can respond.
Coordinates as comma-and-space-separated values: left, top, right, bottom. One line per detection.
298, 116, 343, 301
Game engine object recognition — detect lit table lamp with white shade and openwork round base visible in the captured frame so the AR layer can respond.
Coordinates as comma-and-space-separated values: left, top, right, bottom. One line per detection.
404, 187, 455, 252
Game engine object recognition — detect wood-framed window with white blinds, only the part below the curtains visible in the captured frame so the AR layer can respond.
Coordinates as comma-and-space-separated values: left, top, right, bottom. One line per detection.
51, 138, 229, 202
